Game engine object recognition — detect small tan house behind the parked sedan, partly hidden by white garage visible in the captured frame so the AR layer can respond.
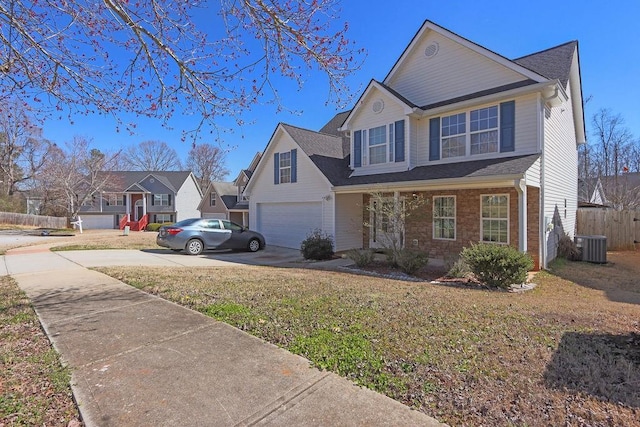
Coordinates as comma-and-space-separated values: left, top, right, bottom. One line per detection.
198, 153, 261, 226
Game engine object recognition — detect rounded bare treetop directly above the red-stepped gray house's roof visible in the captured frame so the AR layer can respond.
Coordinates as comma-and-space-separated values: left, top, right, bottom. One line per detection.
119, 140, 182, 171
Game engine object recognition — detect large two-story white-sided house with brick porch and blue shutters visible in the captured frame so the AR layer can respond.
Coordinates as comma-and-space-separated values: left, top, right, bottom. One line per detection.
245, 21, 585, 267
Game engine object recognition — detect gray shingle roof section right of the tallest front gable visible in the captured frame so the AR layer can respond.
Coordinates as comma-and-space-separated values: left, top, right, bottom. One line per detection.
513, 40, 578, 88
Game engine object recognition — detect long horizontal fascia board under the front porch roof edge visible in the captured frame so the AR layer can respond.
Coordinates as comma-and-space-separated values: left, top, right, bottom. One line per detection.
331, 174, 524, 194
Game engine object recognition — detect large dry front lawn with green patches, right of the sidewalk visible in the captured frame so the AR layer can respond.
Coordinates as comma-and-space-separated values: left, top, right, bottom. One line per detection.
102, 256, 640, 425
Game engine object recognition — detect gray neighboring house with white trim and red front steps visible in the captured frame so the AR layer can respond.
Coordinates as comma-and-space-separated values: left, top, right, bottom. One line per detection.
79, 171, 202, 230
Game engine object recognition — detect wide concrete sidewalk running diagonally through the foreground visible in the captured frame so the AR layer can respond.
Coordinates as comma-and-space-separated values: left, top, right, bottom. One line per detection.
0, 249, 440, 426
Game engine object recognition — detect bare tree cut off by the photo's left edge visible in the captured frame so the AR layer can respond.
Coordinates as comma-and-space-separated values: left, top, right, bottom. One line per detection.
0, 103, 51, 196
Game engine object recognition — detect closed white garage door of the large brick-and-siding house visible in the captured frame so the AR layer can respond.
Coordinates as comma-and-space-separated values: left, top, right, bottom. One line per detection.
257, 202, 322, 249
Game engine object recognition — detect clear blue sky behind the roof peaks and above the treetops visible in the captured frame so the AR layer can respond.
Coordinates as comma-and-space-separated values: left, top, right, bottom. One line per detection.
44, 0, 640, 180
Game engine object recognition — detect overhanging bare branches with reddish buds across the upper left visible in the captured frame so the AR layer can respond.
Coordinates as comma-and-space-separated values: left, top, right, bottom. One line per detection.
0, 0, 362, 137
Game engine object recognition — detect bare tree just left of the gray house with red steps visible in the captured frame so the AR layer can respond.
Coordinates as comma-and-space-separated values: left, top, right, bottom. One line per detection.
39, 137, 119, 217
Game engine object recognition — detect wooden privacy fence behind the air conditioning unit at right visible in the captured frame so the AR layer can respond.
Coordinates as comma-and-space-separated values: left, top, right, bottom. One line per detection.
576, 209, 640, 251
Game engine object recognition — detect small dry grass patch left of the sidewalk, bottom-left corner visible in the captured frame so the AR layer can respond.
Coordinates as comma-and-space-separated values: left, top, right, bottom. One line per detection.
0, 276, 80, 426
